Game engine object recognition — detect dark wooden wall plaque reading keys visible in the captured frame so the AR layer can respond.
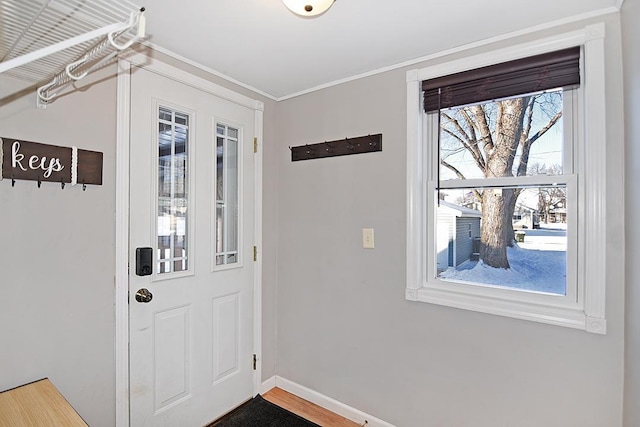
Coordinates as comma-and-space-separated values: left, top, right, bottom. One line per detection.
0, 138, 102, 185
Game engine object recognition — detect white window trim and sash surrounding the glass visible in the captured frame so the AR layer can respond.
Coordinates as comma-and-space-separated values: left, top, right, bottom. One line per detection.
406, 23, 606, 334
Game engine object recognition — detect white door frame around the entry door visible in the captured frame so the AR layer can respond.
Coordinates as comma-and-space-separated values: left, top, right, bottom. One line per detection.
115, 54, 264, 427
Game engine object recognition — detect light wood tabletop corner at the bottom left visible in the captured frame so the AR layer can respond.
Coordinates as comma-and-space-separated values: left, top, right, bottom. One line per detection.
0, 378, 87, 427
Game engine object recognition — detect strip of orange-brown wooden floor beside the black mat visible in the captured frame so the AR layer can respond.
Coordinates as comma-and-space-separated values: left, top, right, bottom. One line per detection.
262, 387, 360, 427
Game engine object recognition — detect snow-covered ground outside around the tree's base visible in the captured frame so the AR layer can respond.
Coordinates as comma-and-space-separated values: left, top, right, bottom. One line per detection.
439, 224, 567, 295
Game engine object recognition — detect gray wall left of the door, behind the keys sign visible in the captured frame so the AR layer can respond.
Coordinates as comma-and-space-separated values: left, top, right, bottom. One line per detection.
0, 68, 116, 426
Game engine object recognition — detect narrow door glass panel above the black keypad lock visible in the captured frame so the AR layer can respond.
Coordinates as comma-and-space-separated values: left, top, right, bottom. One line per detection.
157, 107, 189, 274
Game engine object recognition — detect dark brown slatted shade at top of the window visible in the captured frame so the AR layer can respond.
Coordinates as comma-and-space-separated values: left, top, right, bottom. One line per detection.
422, 46, 580, 112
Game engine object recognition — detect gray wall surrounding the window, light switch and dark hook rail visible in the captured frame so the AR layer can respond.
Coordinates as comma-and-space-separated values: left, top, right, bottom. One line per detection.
276, 14, 624, 427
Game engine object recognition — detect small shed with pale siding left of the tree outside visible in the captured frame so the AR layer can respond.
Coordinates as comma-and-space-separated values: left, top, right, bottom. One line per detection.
436, 200, 482, 271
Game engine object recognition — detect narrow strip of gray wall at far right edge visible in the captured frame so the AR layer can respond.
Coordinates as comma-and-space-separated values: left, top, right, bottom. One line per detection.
622, 0, 640, 427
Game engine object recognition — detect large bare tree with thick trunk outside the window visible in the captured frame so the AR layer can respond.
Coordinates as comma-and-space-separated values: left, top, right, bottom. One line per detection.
440, 92, 562, 268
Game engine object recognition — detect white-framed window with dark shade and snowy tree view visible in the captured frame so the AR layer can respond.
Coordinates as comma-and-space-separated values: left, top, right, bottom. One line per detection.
406, 25, 606, 333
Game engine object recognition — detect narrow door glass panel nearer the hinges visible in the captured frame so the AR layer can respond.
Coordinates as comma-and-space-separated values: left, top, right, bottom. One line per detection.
215, 124, 240, 265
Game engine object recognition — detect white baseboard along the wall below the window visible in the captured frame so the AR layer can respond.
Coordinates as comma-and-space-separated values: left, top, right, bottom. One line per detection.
261, 375, 395, 427
